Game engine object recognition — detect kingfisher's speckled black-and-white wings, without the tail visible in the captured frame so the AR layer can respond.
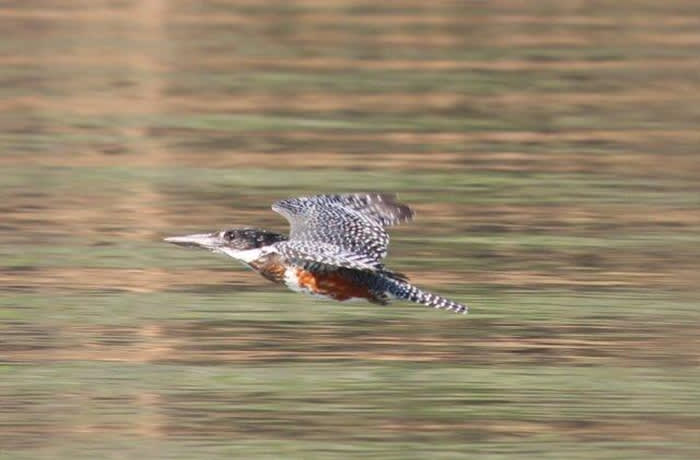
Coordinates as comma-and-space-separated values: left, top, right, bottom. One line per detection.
272, 193, 413, 270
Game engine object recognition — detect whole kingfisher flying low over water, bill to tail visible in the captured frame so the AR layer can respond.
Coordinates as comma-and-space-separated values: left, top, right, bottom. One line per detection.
165, 194, 467, 313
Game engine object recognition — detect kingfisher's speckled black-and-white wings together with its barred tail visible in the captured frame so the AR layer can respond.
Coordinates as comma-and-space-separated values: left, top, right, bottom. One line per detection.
272, 193, 467, 313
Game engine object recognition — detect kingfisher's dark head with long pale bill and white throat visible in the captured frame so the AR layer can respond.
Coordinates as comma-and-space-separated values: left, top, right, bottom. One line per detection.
164, 228, 287, 262
